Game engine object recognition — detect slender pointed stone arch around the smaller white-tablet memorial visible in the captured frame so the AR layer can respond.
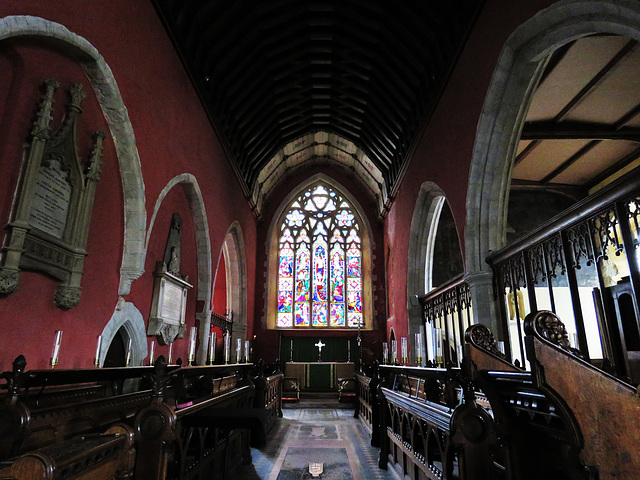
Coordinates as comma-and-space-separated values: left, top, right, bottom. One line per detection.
144, 173, 212, 361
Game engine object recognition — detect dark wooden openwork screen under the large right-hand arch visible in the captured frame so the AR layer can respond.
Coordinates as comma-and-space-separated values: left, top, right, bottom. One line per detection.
487, 171, 640, 384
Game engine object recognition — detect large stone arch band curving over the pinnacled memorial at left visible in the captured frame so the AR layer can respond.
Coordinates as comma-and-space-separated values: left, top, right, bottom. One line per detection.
0, 15, 146, 295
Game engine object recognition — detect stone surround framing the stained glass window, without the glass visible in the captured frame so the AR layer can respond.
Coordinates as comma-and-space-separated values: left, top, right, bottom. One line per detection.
262, 173, 375, 330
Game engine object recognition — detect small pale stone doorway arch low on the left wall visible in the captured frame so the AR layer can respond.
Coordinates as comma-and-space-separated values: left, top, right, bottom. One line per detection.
100, 298, 148, 367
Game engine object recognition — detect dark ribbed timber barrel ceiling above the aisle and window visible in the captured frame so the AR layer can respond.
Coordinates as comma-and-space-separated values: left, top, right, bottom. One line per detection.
153, 0, 482, 214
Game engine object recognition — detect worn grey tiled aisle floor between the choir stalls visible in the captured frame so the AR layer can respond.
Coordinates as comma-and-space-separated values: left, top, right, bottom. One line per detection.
238, 402, 396, 480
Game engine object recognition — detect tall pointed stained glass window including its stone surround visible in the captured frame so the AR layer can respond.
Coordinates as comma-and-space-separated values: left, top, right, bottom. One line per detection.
266, 174, 372, 330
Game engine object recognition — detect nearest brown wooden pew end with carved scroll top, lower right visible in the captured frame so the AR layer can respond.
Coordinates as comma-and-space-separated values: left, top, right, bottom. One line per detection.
525, 311, 640, 480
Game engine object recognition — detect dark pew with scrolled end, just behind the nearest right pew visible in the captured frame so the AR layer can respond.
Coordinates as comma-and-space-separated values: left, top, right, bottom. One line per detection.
463, 325, 596, 480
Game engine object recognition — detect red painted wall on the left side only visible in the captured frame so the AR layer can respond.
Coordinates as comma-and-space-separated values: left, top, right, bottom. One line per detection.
0, 0, 256, 370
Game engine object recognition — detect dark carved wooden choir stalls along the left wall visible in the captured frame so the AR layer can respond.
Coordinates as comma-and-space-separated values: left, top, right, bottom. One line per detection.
0, 358, 282, 480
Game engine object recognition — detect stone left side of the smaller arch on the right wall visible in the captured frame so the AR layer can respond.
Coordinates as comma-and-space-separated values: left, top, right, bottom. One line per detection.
407, 182, 445, 344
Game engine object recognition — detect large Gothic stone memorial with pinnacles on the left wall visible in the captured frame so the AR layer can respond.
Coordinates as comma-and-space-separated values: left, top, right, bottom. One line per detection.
0, 79, 105, 309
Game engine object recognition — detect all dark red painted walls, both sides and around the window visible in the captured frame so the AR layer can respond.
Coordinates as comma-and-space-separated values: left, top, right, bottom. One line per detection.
0, 0, 564, 370
